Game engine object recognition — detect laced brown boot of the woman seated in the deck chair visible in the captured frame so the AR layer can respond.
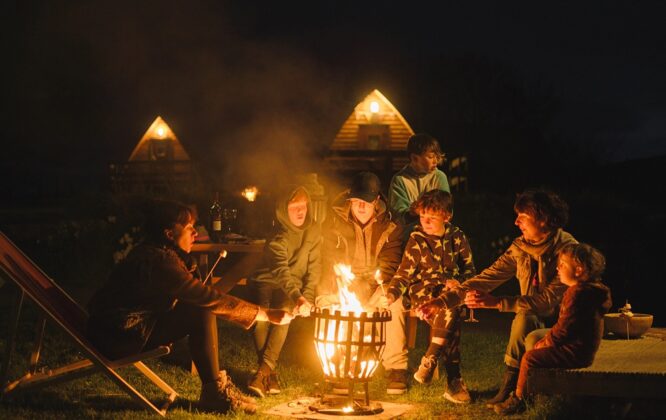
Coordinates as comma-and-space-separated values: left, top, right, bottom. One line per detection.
199, 371, 257, 414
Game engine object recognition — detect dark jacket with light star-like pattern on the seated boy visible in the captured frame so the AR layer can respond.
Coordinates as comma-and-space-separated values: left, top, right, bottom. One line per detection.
388, 223, 476, 305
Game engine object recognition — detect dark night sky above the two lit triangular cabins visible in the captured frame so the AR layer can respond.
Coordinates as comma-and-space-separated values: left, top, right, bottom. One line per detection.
5, 0, 666, 198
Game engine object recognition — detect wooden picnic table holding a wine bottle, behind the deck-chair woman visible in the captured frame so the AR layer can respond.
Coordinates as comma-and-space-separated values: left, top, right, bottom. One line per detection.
191, 239, 266, 293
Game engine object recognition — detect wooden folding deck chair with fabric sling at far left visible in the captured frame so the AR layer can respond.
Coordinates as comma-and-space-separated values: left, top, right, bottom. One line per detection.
0, 232, 178, 416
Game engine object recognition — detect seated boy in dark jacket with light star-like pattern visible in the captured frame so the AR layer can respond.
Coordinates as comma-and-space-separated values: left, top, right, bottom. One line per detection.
387, 190, 476, 404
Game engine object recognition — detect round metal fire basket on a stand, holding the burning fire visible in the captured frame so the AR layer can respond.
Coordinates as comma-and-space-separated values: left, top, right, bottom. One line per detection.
310, 308, 391, 415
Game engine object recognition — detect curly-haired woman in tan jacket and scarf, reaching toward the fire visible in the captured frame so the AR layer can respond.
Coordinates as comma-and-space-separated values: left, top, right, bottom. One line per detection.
417, 189, 577, 408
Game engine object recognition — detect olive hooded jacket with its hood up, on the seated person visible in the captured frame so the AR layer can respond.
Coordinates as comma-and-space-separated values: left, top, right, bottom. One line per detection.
250, 187, 322, 303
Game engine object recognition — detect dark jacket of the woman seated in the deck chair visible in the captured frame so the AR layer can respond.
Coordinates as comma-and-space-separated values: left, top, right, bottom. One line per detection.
87, 244, 259, 357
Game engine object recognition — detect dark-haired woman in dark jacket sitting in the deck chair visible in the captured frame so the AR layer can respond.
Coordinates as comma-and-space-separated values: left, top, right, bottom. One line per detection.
87, 201, 291, 413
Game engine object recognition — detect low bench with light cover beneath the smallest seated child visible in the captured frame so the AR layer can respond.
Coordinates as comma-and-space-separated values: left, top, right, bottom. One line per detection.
527, 328, 666, 399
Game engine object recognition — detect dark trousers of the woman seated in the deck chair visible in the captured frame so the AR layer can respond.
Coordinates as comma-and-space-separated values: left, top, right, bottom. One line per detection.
143, 302, 220, 384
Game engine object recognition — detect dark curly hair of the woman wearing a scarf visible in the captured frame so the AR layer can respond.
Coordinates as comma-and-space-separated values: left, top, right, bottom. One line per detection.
513, 188, 569, 231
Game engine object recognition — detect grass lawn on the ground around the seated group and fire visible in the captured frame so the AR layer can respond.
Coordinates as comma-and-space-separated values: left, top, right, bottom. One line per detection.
0, 287, 651, 419
